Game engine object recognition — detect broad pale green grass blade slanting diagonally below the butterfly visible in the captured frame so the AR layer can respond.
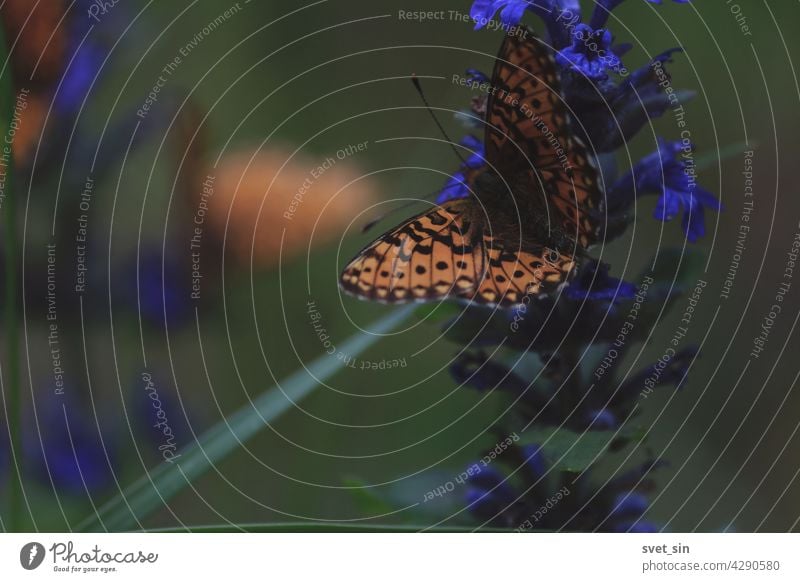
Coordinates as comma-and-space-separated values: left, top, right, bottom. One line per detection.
78, 305, 415, 531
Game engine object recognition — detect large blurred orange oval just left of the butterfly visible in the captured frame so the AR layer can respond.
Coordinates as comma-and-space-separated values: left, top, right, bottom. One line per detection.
206, 149, 377, 267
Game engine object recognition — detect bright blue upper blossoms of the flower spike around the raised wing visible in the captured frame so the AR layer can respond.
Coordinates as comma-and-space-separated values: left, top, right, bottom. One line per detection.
450, 0, 720, 242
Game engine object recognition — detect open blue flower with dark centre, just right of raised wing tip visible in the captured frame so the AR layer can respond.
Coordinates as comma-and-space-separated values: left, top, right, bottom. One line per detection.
556, 23, 624, 81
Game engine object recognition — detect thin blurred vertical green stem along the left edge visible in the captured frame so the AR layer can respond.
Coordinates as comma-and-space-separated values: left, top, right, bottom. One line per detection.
0, 22, 23, 531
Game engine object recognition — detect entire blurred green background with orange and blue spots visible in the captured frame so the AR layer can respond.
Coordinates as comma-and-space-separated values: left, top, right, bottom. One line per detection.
0, 0, 800, 531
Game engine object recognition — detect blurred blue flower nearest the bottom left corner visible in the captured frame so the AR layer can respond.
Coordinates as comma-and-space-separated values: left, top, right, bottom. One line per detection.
25, 386, 116, 495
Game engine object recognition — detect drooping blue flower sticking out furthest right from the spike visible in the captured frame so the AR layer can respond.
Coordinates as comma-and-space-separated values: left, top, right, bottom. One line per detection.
609, 139, 722, 242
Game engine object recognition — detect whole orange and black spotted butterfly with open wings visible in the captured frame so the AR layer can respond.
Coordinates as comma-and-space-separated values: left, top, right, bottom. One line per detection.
340, 30, 603, 306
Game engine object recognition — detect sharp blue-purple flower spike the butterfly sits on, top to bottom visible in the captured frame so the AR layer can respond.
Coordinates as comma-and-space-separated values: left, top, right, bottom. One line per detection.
439, 0, 721, 532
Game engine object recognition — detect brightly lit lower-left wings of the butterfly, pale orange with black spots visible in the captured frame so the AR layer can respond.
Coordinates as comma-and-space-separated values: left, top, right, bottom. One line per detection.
339, 200, 574, 306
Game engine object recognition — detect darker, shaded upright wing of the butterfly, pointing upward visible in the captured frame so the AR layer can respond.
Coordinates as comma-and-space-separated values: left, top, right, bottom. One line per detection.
485, 28, 603, 246
